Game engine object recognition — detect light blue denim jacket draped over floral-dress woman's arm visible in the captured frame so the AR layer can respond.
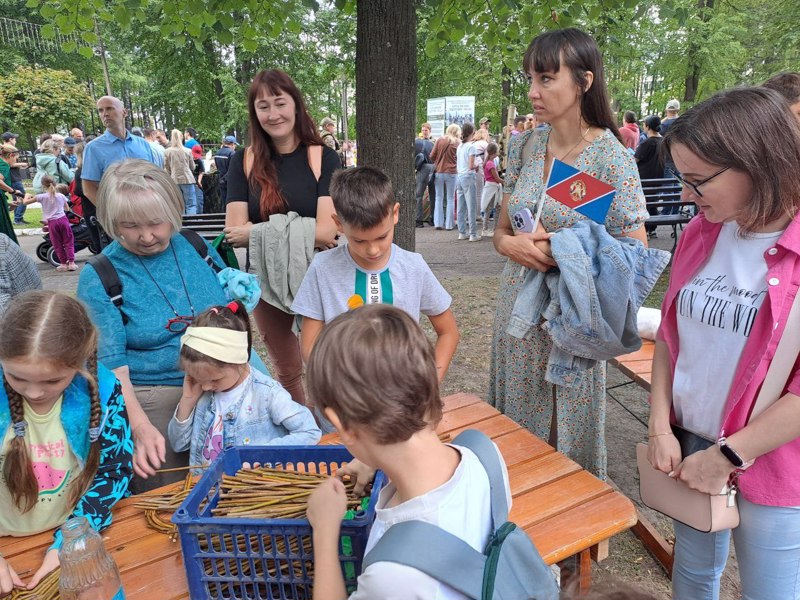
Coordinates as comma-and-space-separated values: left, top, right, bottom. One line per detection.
507, 220, 670, 387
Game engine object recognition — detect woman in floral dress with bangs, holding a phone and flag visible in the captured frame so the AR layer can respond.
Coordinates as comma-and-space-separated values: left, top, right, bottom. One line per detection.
489, 29, 648, 478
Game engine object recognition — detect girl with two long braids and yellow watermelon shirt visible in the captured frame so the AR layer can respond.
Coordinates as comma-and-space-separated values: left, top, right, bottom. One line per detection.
0, 290, 133, 596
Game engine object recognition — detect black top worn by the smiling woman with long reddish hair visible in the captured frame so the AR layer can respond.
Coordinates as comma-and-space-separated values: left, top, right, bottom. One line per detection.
227, 144, 342, 223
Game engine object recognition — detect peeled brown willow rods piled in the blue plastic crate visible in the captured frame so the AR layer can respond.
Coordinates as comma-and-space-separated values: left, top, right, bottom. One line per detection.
211, 467, 361, 519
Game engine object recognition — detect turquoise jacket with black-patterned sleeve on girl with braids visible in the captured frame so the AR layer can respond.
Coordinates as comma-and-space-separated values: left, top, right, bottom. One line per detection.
0, 365, 133, 548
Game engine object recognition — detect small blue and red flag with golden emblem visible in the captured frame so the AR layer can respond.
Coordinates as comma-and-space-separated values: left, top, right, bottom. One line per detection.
547, 159, 617, 224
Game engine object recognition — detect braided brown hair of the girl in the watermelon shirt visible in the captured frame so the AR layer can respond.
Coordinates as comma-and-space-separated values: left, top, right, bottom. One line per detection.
0, 290, 102, 513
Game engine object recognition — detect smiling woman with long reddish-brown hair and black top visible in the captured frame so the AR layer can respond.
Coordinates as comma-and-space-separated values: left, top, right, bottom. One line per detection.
225, 69, 341, 404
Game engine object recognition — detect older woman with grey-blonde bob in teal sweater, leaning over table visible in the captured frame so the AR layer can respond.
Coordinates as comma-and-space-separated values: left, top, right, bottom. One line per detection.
78, 159, 260, 493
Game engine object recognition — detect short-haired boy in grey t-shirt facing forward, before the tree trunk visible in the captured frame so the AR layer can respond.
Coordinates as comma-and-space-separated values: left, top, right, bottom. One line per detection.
292, 167, 460, 381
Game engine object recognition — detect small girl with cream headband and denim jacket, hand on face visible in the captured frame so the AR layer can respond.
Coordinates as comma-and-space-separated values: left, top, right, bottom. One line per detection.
167, 300, 322, 467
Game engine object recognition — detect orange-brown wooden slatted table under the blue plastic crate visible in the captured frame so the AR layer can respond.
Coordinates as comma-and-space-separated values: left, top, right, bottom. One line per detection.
0, 394, 636, 600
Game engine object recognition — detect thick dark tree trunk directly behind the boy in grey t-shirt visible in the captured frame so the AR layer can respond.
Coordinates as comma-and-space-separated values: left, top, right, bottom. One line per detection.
356, 0, 417, 251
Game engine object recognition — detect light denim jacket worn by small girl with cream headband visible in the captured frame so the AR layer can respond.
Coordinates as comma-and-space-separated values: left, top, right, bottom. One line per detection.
167, 368, 322, 465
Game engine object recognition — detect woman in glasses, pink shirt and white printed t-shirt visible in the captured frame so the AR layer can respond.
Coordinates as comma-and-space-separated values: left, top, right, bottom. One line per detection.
648, 88, 800, 600
